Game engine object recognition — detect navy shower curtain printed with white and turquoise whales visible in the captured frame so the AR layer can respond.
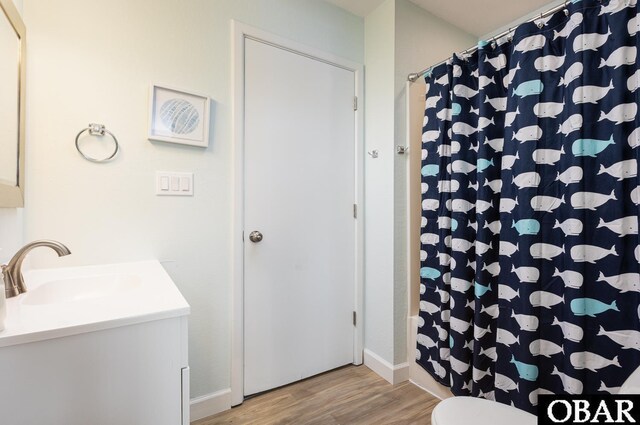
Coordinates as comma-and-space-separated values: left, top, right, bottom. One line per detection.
416, 0, 640, 412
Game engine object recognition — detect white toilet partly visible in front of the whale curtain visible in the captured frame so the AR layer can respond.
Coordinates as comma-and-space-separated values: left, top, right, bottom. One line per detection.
431, 368, 640, 425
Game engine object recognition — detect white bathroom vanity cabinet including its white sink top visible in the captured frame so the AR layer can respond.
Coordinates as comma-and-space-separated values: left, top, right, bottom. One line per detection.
0, 262, 189, 425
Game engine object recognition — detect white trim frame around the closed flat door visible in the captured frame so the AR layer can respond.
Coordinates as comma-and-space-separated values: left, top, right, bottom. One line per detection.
231, 20, 364, 406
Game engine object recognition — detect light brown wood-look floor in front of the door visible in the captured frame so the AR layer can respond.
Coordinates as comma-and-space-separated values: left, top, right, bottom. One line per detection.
192, 366, 438, 425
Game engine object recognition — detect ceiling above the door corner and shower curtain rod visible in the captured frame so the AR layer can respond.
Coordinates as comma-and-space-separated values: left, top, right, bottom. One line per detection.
326, 0, 559, 37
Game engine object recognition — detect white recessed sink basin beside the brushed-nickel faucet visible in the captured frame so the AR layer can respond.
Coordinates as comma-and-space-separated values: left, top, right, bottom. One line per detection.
22, 274, 141, 306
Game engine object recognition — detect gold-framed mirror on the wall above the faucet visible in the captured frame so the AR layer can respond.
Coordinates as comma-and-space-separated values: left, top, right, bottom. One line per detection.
0, 0, 26, 208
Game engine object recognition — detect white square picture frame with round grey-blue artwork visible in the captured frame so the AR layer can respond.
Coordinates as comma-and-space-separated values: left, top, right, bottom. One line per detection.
148, 84, 211, 148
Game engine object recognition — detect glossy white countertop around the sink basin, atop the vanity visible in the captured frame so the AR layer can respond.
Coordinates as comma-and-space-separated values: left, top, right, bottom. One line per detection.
0, 260, 190, 347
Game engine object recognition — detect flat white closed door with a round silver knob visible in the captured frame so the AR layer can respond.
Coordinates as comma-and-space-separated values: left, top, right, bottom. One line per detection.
244, 39, 356, 395
